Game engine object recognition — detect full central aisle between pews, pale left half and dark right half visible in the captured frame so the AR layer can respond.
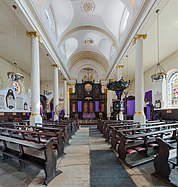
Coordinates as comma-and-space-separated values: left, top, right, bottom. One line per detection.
30, 126, 135, 187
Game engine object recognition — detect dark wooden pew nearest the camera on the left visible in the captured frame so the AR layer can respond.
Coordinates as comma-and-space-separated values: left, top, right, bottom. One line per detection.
0, 136, 57, 184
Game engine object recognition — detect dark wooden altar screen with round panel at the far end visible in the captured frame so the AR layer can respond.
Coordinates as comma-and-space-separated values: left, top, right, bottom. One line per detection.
70, 81, 107, 118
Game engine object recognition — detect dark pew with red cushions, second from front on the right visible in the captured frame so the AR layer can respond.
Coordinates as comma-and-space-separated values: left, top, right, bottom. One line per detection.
118, 124, 176, 167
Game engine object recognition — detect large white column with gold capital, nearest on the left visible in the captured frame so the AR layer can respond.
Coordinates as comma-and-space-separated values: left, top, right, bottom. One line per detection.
27, 32, 42, 125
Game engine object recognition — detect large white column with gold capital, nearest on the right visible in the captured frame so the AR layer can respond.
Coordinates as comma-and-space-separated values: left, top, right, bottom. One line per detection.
134, 35, 146, 124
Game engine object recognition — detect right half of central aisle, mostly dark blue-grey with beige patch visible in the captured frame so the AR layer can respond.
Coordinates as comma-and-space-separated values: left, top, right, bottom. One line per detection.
89, 127, 136, 187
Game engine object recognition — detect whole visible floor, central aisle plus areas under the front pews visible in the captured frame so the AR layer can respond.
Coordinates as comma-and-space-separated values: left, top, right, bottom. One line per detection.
0, 126, 171, 187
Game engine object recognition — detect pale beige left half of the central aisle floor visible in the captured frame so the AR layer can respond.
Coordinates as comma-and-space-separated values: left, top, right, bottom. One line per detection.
48, 127, 90, 187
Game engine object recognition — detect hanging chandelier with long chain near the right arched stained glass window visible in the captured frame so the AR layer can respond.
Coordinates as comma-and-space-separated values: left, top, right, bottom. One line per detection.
151, 9, 166, 82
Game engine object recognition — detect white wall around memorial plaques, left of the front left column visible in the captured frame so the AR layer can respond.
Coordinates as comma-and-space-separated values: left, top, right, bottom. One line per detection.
0, 57, 31, 112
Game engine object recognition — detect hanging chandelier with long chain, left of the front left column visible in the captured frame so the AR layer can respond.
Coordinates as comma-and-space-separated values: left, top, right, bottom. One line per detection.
7, 5, 24, 82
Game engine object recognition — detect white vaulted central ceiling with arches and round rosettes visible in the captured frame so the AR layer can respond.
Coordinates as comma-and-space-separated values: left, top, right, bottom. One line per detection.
20, 0, 146, 79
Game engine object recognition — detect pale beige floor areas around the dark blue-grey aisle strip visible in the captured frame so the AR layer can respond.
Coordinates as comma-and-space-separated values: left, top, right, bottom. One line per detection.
29, 127, 171, 187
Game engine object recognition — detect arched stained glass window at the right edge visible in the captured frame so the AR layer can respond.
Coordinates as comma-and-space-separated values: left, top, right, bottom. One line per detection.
168, 71, 178, 107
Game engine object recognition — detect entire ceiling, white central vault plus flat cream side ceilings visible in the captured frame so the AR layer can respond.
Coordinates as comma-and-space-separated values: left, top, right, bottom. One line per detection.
0, 0, 178, 84
